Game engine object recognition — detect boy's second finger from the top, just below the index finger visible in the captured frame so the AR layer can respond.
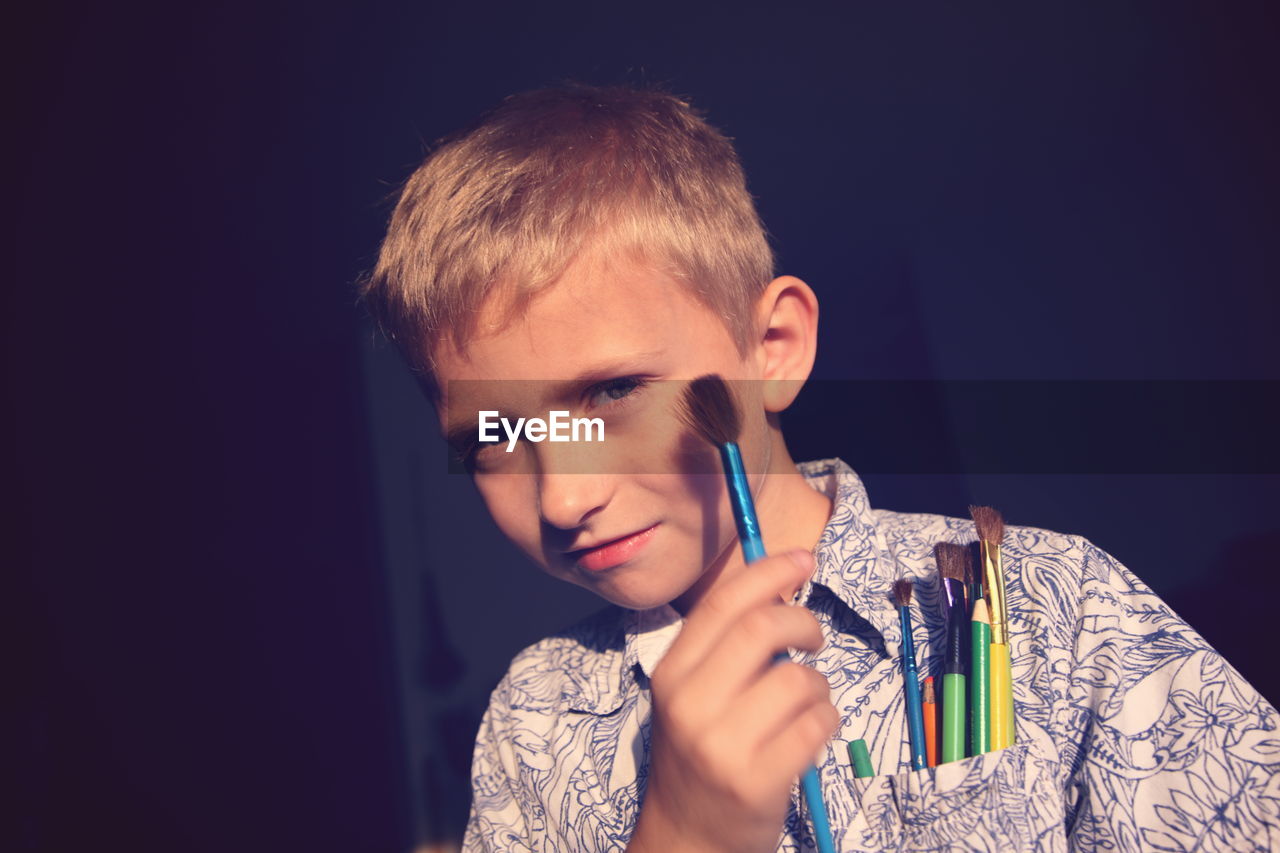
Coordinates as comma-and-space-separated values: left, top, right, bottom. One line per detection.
668, 605, 823, 725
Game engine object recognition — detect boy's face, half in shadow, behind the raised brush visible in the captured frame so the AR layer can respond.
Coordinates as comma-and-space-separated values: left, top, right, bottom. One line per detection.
435, 252, 769, 610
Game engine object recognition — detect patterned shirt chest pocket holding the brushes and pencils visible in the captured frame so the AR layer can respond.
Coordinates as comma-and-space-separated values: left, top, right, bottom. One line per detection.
841, 742, 1066, 853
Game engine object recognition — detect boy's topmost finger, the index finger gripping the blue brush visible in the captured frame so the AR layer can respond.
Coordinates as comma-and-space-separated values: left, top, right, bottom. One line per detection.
663, 551, 814, 674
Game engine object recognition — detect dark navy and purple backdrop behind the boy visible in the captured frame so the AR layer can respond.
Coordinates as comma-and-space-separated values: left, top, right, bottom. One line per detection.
12, 3, 1280, 852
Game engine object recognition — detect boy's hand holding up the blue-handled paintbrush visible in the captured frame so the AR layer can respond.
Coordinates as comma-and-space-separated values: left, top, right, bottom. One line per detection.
627, 551, 840, 853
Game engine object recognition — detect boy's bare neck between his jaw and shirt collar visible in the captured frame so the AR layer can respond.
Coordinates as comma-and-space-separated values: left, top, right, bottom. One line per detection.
671, 430, 832, 615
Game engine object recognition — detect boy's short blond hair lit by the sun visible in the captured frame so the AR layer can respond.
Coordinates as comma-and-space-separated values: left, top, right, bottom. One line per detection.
361, 86, 773, 388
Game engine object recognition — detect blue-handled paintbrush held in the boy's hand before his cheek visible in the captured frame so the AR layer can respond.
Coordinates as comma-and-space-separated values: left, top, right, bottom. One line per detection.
680, 374, 836, 853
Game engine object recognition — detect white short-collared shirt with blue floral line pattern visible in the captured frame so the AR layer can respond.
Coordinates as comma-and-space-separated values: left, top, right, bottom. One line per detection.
463, 460, 1280, 853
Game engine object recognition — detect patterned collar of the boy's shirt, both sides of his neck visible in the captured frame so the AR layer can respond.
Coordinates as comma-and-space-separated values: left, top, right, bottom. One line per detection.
625, 459, 901, 678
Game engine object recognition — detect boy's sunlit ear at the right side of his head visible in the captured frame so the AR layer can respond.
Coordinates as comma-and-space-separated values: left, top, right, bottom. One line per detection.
756, 275, 818, 412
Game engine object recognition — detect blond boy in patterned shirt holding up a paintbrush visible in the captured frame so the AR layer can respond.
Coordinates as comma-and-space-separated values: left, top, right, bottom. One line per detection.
365, 87, 1280, 852
